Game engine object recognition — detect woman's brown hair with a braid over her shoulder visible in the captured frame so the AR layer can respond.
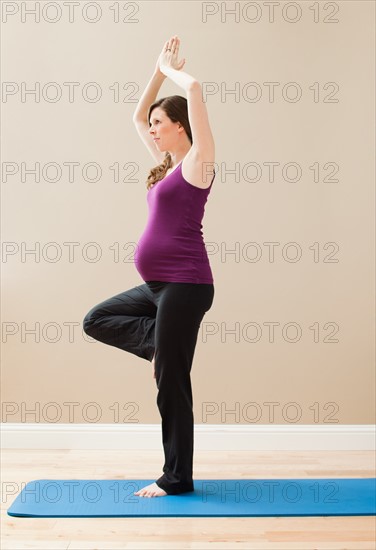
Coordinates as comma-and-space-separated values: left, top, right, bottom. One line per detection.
146, 95, 193, 190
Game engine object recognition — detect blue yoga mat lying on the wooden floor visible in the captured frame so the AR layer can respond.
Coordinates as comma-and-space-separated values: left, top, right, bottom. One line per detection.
8, 478, 376, 518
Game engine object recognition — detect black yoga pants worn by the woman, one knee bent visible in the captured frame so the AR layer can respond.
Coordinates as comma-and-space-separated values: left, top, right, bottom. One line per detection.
83, 281, 214, 494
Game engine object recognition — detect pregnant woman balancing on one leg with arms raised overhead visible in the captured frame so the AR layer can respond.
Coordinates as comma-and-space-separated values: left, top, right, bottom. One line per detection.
83, 36, 215, 497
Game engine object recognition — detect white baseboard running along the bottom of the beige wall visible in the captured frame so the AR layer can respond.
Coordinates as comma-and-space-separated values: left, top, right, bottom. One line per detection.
0, 423, 376, 451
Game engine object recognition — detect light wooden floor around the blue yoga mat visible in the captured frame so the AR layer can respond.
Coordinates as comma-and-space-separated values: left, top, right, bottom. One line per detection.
1, 450, 376, 550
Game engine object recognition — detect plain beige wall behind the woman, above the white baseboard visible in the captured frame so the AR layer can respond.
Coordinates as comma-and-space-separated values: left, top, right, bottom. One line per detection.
1, 1, 375, 424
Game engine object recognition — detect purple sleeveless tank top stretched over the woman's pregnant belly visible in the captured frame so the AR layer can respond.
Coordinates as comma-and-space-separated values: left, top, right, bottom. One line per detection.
134, 161, 216, 284
